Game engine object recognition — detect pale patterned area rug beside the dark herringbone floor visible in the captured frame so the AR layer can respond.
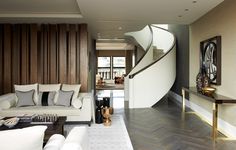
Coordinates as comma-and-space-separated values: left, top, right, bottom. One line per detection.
65, 115, 133, 150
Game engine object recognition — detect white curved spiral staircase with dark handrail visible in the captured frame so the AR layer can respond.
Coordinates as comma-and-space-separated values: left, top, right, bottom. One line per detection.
125, 25, 176, 108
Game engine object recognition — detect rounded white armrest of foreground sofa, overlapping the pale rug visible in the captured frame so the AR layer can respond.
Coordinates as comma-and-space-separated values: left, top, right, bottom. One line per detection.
61, 126, 89, 150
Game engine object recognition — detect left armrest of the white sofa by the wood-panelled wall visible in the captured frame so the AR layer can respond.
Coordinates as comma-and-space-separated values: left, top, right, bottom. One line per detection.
0, 93, 16, 109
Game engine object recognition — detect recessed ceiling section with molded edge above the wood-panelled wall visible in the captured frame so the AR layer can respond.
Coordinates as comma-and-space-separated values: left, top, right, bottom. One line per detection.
0, 0, 82, 18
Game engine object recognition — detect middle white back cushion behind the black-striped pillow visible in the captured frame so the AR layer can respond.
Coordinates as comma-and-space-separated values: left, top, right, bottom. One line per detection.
39, 84, 61, 103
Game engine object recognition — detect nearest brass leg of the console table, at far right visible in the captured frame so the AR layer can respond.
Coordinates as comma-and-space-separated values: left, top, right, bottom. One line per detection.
212, 103, 218, 140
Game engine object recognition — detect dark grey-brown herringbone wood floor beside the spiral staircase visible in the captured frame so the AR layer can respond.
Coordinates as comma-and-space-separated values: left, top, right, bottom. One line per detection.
115, 97, 236, 150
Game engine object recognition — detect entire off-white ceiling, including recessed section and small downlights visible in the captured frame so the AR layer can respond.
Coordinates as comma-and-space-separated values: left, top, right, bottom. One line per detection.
0, 0, 223, 39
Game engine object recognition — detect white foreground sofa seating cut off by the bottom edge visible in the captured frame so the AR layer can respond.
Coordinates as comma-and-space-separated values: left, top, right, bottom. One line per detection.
0, 126, 89, 150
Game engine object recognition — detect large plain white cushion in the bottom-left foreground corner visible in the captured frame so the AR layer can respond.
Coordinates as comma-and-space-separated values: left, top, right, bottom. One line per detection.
0, 126, 47, 150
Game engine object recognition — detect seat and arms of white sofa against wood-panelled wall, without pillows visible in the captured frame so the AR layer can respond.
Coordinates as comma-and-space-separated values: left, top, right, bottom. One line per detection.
0, 83, 94, 125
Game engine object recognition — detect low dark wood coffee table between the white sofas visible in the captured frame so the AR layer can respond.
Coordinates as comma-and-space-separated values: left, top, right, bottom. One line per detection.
0, 116, 66, 143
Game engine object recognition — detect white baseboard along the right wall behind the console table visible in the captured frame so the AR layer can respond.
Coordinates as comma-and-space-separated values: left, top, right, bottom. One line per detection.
169, 91, 236, 138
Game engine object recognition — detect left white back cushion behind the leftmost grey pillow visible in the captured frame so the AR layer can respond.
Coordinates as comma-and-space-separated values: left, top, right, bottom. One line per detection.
14, 83, 38, 104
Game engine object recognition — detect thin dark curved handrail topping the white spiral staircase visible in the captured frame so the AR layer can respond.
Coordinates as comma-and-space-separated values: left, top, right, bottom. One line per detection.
129, 25, 176, 79
